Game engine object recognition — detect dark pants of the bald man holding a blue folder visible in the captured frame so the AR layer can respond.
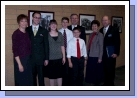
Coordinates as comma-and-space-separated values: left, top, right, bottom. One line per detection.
103, 57, 116, 86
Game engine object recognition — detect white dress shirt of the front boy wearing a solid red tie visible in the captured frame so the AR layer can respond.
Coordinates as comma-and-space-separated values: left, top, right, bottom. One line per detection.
67, 37, 87, 58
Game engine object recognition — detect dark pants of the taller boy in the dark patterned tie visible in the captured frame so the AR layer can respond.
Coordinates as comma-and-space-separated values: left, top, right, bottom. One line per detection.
62, 58, 69, 86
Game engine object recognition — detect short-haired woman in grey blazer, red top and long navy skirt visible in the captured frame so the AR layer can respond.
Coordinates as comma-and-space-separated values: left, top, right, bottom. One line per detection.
85, 20, 104, 85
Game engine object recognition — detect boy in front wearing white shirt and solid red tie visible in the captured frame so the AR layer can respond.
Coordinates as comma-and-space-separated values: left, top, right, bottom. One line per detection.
67, 27, 87, 86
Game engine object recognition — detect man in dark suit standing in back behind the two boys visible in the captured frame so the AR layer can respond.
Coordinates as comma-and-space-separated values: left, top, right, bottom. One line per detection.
68, 14, 86, 43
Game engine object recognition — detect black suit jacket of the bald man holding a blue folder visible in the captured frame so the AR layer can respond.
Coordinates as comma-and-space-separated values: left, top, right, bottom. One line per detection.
100, 25, 120, 56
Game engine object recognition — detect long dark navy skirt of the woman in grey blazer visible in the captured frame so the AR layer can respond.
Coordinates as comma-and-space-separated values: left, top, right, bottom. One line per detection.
85, 57, 104, 84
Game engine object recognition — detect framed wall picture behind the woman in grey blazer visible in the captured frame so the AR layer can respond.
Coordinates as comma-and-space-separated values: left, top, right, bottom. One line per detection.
79, 14, 96, 34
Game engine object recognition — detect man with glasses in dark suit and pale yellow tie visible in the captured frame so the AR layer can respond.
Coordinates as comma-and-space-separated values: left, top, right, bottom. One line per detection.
26, 12, 49, 86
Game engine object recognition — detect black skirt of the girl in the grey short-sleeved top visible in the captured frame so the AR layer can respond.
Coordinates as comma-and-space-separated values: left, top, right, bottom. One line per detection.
44, 59, 63, 79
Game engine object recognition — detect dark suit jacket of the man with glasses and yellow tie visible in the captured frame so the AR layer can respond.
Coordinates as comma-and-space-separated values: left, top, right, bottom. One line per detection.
26, 26, 49, 64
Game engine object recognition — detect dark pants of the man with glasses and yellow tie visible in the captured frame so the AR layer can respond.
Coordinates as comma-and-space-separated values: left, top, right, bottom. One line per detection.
31, 60, 45, 86
